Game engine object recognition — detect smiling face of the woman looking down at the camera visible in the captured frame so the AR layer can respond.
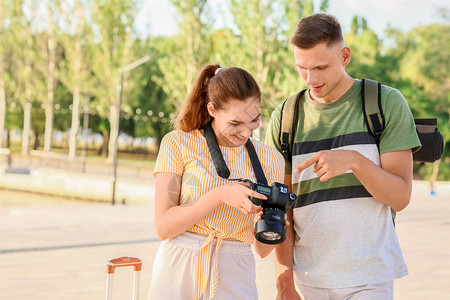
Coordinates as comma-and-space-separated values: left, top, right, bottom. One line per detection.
208, 97, 261, 147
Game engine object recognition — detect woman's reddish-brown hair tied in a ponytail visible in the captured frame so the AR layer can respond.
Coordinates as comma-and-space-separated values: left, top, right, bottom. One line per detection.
174, 64, 261, 132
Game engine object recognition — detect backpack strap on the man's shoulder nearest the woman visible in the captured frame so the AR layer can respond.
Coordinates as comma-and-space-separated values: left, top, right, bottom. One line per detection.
279, 90, 306, 161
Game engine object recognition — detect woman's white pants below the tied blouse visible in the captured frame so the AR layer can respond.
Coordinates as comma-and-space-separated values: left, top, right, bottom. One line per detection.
147, 232, 258, 300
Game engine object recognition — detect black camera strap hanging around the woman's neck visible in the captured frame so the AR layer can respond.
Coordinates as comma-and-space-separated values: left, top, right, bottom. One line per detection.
204, 123, 267, 185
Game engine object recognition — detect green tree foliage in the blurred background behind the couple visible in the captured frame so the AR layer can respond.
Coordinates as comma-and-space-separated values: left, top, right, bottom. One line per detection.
0, 0, 450, 180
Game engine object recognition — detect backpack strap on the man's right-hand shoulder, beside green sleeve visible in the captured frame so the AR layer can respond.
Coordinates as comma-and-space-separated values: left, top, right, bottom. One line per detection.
361, 79, 384, 145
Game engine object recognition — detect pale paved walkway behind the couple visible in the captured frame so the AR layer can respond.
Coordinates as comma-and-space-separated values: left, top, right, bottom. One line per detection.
0, 182, 450, 300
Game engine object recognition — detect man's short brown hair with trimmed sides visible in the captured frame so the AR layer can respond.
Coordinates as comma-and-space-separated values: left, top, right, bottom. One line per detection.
290, 13, 344, 49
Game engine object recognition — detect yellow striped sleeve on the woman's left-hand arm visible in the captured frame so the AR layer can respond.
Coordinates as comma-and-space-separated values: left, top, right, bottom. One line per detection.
153, 131, 184, 176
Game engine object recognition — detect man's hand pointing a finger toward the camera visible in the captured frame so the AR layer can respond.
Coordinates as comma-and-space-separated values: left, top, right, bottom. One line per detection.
294, 150, 359, 182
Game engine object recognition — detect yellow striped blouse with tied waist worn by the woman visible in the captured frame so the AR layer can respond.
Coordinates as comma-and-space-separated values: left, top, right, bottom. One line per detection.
154, 130, 284, 298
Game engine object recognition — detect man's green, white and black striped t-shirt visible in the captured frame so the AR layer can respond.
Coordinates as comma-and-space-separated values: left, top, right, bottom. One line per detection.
266, 80, 420, 288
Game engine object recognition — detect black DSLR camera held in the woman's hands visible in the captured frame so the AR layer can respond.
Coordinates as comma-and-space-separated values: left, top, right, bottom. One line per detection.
245, 180, 297, 244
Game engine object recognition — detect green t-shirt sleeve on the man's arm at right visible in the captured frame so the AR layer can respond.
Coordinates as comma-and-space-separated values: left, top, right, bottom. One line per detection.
380, 89, 421, 154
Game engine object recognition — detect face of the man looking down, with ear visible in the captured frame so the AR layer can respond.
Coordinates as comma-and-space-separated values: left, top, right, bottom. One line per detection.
294, 43, 350, 103
